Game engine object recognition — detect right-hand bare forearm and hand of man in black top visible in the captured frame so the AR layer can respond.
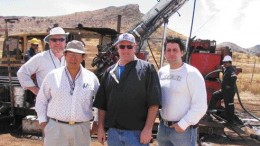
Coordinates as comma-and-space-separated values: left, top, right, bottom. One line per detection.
140, 105, 159, 144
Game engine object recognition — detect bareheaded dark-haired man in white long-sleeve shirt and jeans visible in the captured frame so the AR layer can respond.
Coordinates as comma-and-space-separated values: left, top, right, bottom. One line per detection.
157, 37, 207, 146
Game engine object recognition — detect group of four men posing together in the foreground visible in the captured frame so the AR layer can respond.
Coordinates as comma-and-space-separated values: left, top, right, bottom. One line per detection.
17, 27, 234, 146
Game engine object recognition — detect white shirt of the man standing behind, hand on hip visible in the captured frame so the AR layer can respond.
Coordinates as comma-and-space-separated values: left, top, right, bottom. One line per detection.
17, 50, 65, 88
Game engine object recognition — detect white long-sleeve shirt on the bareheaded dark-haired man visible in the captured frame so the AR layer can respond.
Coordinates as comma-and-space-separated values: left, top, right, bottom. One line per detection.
158, 63, 207, 129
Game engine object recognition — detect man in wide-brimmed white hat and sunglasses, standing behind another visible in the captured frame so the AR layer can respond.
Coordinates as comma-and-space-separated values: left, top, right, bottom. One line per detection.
17, 27, 68, 95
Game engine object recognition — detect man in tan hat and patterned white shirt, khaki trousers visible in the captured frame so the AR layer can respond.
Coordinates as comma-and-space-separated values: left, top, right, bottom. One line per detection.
35, 40, 99, 146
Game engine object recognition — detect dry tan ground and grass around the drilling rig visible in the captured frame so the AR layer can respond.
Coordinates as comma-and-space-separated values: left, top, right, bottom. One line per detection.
0, 50, 260, 146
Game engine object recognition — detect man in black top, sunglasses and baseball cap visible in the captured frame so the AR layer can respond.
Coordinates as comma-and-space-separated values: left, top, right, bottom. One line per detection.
93, 33, 161, 146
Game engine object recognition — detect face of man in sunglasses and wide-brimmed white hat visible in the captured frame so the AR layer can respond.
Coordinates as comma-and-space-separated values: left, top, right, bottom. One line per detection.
49, 35, 66, 52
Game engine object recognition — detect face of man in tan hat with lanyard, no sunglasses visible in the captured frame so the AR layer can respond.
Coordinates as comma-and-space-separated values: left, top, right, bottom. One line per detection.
64, 51, 84, 68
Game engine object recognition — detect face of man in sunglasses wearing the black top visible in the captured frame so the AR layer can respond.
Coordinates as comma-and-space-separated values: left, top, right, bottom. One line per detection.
116, 41, 135, 63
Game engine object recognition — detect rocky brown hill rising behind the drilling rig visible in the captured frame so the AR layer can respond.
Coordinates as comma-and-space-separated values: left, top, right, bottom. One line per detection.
0, 4, 186, 38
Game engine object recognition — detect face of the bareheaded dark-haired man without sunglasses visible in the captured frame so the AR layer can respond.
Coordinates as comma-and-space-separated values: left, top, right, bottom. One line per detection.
164, 43, 183, 64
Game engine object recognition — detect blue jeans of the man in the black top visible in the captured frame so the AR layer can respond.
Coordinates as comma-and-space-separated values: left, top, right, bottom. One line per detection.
107, 128, 149, 146
